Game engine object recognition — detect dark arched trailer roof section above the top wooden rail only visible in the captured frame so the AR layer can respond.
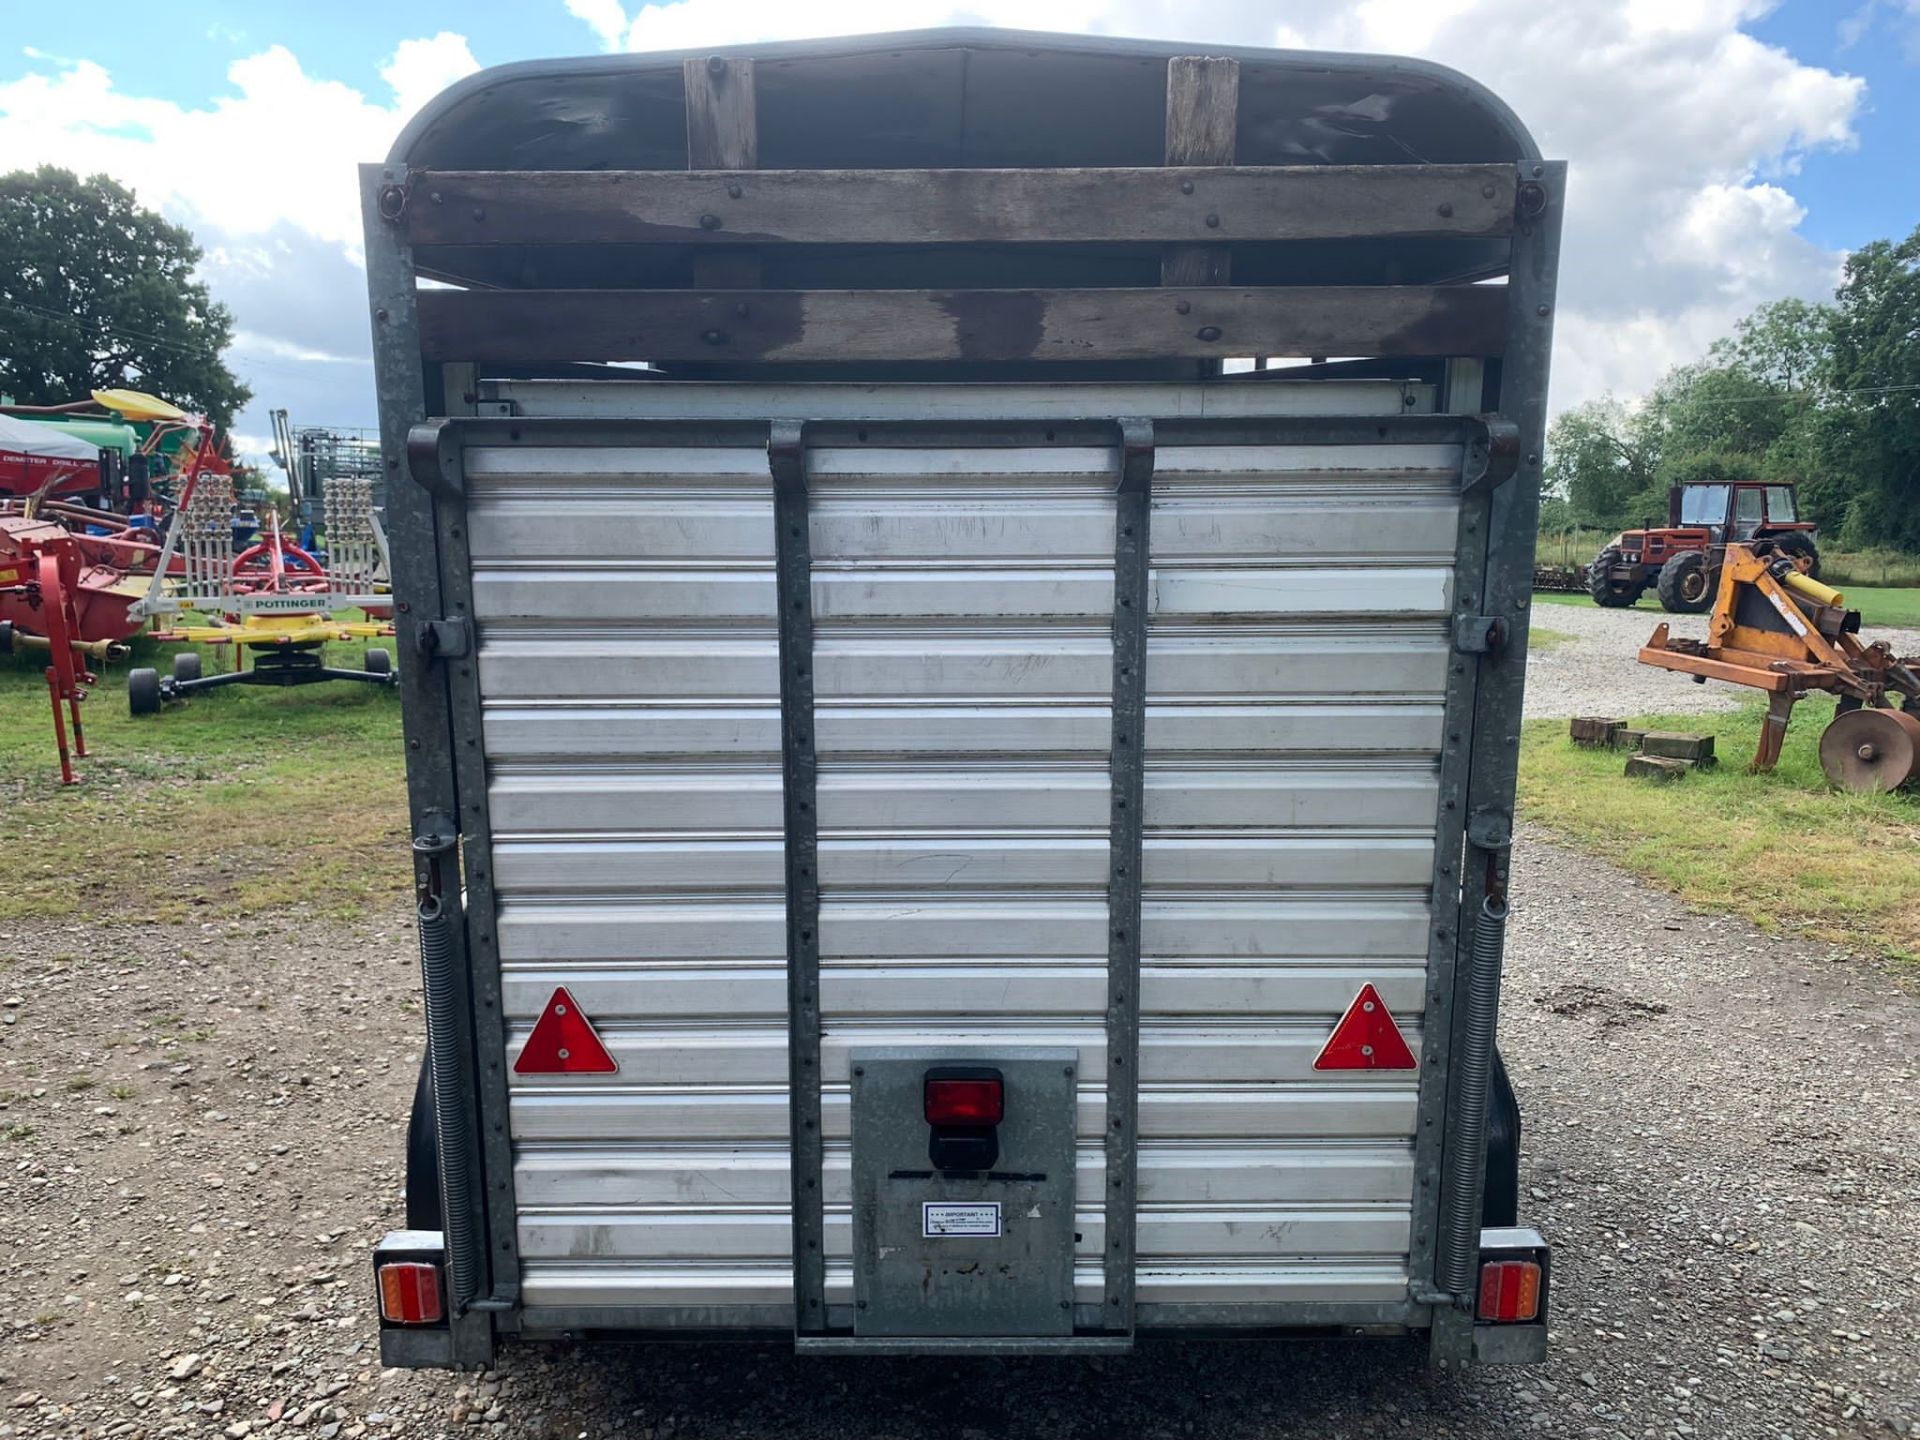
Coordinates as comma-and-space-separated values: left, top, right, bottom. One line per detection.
390, 29, 1538, 171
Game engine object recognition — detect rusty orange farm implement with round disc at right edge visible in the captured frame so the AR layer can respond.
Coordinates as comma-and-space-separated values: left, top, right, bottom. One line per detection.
1640, 540, 1920, 791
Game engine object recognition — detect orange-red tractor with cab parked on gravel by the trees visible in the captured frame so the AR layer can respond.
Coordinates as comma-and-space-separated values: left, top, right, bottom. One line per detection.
1586, 480, 1820, 614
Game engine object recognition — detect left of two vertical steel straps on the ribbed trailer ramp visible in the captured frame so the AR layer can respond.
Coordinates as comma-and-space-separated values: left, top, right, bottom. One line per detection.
766, 420, 828, 1334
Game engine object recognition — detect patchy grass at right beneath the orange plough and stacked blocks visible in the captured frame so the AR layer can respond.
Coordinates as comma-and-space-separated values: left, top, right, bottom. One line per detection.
1521, 699, 1920, 962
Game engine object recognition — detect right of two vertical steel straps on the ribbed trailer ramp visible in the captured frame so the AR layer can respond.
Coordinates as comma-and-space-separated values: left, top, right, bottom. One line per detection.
1100, 420, 1154, 1334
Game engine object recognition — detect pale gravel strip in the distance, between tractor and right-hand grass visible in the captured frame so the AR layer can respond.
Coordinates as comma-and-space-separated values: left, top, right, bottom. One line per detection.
1526, 605, 1920, 718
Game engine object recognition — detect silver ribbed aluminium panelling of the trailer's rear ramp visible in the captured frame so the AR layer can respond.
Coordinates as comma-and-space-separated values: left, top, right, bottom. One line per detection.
467, 382, 1461, 1328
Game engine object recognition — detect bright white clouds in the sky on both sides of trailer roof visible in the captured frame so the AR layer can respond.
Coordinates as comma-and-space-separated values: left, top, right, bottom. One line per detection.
0, 0, 1866, 432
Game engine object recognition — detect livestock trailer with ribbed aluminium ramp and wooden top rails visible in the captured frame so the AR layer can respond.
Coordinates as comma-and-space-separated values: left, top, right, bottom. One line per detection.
363, 31, 1565, 1367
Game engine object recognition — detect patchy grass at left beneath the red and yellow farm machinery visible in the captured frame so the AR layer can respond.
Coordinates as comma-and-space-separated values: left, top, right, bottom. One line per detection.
0, 641, 411, 920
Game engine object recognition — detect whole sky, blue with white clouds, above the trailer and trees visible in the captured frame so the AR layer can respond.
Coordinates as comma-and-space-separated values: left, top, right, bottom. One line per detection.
0, 0, 1920, 444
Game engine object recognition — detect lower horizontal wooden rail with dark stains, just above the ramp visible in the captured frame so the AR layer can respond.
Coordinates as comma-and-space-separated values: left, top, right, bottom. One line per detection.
419, 286, 1505, 363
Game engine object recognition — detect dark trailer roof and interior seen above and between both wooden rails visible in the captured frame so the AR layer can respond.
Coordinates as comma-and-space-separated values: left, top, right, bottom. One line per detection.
390, 29, 1538, 299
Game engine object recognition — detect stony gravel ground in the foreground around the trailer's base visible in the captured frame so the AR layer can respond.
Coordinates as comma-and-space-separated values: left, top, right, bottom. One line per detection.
0, 833, 1920, 1440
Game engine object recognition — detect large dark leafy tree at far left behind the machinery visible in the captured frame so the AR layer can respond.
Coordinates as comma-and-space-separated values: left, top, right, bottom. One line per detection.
0, 165, 252, 430
